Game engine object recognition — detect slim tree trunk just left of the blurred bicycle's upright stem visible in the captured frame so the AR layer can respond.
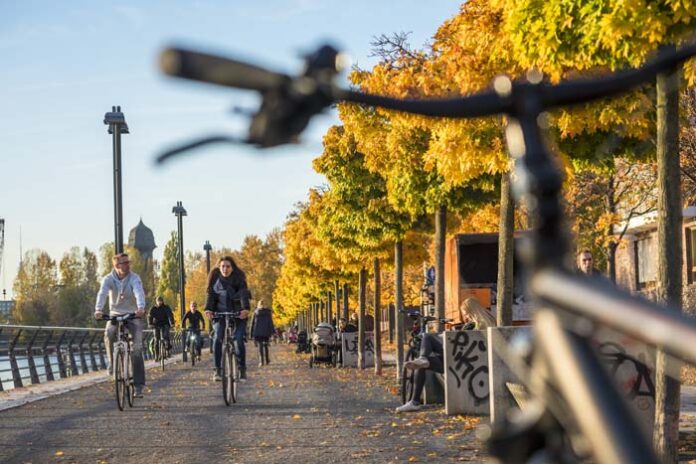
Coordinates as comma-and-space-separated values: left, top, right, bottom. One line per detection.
496, 172, 515, 327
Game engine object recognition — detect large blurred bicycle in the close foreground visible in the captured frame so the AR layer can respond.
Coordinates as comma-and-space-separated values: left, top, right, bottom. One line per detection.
157, 45, 696, 463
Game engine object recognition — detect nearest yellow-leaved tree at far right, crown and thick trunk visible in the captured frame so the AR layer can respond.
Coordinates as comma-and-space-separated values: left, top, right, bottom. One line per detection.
500, 0, 696, 462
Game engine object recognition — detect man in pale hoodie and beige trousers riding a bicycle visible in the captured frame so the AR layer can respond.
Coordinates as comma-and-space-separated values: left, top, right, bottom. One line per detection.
94, 253, 145, 398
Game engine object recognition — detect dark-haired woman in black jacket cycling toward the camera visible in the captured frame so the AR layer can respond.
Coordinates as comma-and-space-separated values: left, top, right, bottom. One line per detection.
205, 256, 250, 381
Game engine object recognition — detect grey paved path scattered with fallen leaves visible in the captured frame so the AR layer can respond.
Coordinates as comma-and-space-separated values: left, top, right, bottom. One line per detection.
0, 344, 482, 464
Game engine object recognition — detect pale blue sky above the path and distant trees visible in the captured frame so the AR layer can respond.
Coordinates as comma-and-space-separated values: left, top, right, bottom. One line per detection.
0, 0, 460, 292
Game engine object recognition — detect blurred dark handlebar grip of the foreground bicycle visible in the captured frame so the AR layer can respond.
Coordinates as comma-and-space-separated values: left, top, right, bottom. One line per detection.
159, 48, 290, 92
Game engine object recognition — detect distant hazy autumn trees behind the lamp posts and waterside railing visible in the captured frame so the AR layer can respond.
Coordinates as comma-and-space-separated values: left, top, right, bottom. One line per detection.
11, 230, 283, 327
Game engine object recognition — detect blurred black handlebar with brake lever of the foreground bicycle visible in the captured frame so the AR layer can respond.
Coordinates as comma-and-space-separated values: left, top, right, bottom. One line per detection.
159, 45, 696, 154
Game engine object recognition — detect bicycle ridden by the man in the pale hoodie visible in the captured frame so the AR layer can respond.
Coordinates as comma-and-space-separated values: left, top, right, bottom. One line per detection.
102, 314, 135, 411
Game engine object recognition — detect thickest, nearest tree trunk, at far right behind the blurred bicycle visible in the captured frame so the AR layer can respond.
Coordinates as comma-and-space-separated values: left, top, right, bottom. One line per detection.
653, 54, 682, 463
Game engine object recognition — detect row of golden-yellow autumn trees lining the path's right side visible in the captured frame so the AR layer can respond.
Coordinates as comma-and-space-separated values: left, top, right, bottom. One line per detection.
276, 0, 696, 461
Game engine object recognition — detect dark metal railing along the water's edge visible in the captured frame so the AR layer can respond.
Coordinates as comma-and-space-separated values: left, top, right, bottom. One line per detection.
0, 325, 188, 391
